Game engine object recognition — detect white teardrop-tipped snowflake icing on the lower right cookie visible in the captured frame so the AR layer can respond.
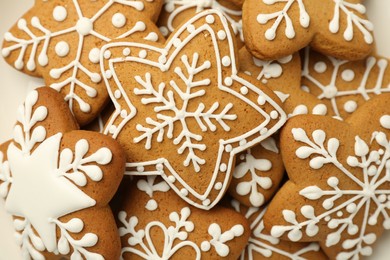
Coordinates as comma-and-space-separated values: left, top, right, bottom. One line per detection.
271, 115, 390, 259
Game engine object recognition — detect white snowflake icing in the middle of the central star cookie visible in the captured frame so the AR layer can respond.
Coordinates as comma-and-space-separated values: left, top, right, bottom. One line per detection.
134, 53, 237, 172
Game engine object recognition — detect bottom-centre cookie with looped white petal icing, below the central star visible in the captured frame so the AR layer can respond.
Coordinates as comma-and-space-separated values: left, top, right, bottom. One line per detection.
117, 176, 250, 260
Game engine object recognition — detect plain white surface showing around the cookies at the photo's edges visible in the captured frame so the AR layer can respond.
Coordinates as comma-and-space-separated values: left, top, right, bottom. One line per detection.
0, 0, 390, 260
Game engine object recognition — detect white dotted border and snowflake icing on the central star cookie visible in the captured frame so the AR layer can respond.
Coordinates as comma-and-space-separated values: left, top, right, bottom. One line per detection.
102, 10, 286, 209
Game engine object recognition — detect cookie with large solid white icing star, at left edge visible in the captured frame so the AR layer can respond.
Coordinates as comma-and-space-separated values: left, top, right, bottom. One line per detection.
0, 87, 125, 259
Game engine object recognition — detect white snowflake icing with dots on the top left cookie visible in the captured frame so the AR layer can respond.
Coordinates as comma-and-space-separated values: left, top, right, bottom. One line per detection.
2, 0, 155, 116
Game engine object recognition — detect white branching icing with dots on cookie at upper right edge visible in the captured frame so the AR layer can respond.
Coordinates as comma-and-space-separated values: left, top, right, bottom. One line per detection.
302, 48, 390, 118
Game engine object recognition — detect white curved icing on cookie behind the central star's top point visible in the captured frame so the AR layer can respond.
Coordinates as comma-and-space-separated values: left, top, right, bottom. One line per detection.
160, 0, 244, 42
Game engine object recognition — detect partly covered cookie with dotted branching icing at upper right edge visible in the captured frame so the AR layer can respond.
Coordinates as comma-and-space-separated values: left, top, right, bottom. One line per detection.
302, 48, 390, 119
